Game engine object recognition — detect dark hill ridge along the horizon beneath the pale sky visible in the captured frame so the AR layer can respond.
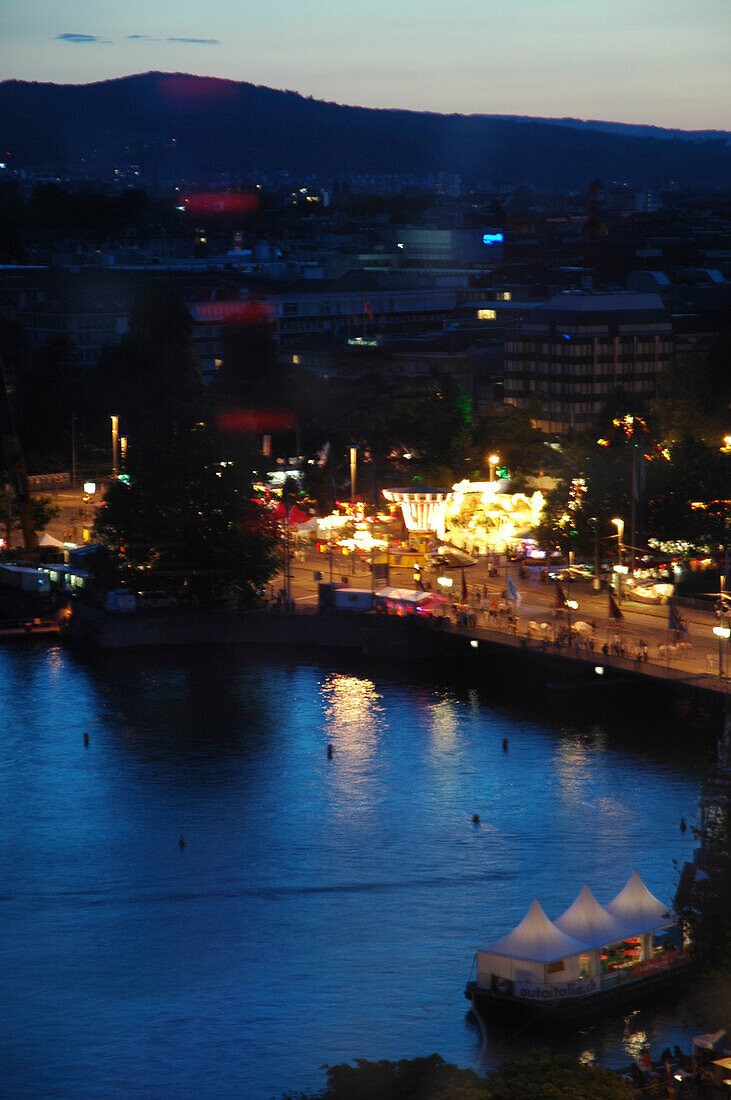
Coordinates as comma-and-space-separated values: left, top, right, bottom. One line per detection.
0, 73, 731, 191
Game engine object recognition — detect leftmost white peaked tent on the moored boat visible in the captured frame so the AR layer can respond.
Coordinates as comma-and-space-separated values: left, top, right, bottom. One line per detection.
477, 899, 591, 985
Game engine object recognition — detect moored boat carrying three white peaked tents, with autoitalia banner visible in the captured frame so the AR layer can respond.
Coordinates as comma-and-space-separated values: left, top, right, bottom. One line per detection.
465, 871, 690, 1020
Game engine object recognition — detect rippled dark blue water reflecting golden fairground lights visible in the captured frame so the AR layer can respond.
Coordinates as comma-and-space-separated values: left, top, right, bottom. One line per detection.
0, 647, 702, 1100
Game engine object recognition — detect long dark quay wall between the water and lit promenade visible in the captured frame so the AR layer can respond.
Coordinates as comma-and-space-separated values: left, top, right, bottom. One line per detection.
62, 604, 730, 713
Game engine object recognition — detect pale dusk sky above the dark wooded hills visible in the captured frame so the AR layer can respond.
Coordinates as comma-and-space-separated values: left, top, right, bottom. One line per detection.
0, 0, 731, 130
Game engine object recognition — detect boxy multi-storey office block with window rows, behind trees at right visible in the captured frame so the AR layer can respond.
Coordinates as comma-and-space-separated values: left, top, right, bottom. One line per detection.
505, 293, 673, 432
